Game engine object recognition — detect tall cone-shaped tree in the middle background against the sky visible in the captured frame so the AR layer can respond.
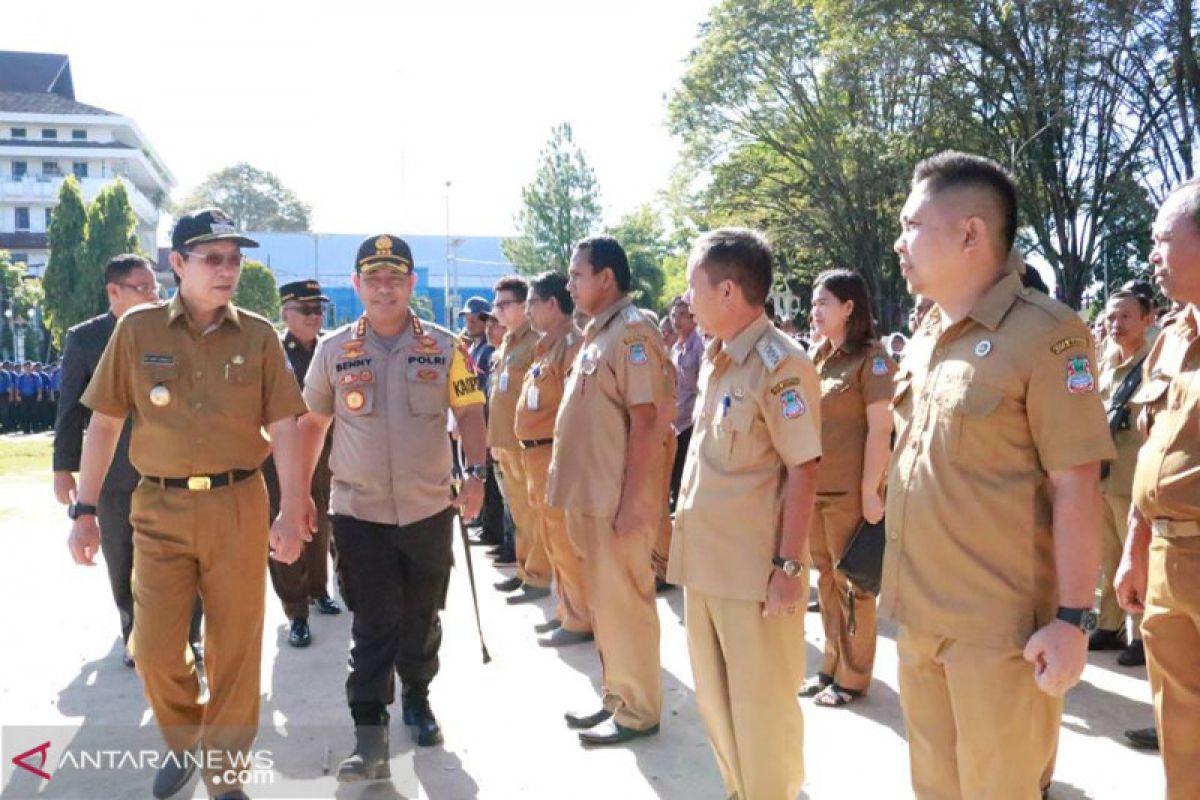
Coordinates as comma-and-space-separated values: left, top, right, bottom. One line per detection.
500, 122, 600, 275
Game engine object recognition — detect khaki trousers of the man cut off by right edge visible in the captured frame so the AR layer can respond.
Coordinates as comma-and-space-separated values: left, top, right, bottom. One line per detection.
1141, 535, 1200, 800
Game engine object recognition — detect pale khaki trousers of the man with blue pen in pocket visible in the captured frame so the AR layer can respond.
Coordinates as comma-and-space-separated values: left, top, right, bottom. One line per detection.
684, 587, 808, 800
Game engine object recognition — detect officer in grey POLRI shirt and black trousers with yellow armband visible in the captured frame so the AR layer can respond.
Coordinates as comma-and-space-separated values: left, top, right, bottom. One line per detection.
301, 234, 486, 781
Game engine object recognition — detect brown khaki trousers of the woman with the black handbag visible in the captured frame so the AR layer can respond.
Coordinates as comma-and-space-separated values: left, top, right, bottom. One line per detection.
809, 492, 876, 692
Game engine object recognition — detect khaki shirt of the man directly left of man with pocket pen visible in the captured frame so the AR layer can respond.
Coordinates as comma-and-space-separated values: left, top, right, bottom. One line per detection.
546, 297, 674, 517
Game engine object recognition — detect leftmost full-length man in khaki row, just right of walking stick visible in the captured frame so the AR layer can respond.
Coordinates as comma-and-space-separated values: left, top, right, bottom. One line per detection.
487, 276, 551, 604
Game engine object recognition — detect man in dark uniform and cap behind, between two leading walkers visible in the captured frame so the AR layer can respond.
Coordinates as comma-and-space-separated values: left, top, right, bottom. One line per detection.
263, 281, 342, 648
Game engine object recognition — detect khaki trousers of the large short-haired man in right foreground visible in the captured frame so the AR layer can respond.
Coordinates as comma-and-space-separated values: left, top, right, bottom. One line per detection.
896, 625, 1062, 800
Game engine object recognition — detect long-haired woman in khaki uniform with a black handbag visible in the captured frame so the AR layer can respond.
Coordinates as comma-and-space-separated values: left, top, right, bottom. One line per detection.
800, 270, 895, 706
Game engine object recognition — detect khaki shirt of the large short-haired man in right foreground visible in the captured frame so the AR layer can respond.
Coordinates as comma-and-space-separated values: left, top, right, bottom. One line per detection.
880, 275, 1116, 648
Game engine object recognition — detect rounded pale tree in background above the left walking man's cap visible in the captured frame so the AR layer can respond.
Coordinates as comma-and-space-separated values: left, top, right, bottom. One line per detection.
179, 162, 312, 230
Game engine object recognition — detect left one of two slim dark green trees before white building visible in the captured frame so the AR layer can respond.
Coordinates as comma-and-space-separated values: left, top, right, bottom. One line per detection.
42, 175, 92, 347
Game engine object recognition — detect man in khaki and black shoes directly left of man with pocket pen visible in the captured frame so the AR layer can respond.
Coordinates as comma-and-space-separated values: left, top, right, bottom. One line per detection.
546, 236, 674, 745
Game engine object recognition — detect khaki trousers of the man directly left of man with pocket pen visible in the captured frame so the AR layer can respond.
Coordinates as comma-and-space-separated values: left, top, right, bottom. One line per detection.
566, 509, 662, 730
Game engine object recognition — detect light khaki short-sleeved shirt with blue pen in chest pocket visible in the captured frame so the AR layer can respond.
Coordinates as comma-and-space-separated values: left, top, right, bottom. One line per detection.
667, 315, 821, 602
